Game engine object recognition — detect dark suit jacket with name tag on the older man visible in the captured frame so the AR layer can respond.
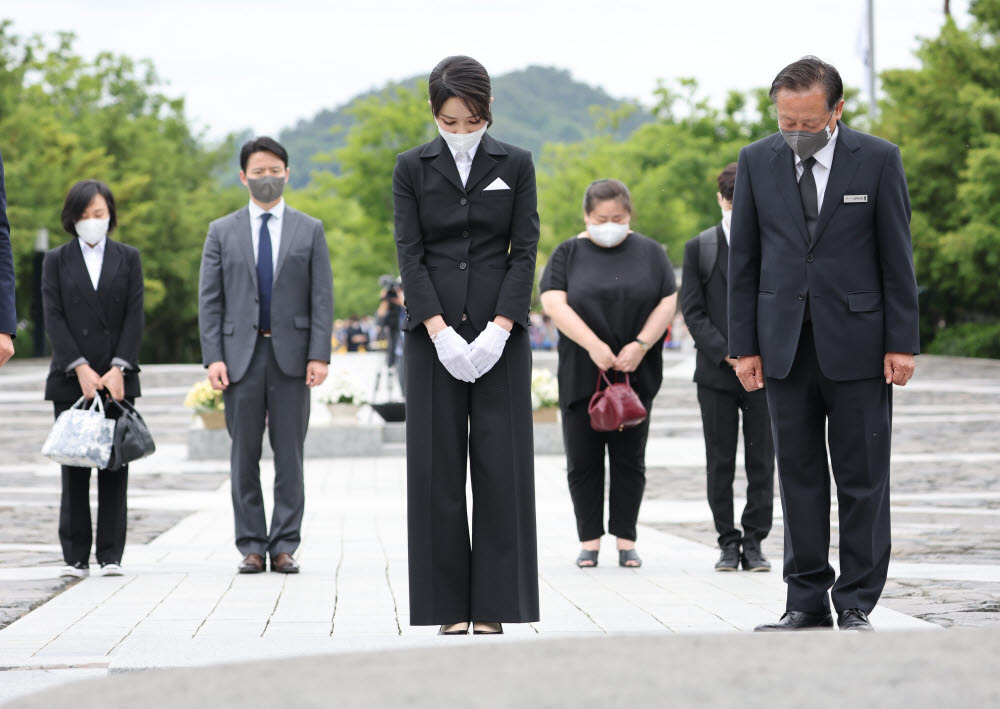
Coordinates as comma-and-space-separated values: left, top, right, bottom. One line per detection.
729, 123, 920, 381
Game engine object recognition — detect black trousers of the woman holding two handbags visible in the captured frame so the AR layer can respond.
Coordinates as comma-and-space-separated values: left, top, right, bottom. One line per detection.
52, 394, 135, 566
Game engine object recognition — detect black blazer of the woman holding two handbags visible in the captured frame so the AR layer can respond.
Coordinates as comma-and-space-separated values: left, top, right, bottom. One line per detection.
42, 238, 145, 401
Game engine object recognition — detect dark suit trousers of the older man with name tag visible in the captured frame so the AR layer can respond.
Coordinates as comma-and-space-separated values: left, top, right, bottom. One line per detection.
765, 323, 892, 613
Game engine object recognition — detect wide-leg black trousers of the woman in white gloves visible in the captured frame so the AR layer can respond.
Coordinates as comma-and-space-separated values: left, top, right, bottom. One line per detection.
404, 326, 538, 625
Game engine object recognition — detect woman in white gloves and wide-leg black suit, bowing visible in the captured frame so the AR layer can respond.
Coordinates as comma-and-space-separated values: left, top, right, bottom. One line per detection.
393, 56, 538, 634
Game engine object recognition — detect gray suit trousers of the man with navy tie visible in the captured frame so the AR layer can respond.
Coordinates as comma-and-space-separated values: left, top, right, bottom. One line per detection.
222, 336, 309, 557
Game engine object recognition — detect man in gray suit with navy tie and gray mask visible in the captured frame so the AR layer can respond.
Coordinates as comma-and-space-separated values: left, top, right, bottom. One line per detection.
198, 137, 333, 574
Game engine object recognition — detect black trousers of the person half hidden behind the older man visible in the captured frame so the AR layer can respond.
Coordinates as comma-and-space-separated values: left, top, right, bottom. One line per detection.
698, 384, 774, 547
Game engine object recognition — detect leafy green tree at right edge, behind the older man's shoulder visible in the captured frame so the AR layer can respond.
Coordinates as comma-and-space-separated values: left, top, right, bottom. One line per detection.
878, 0, 1000, 344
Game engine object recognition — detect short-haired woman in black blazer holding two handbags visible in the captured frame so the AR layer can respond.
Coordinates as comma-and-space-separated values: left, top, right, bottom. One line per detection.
42, 180, 145, 578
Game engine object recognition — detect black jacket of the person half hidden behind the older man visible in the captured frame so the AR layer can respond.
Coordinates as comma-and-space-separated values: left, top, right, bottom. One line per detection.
681, 223, 743, 391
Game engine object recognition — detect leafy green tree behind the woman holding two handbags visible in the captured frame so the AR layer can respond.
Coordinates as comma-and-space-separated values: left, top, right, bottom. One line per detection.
0, 23, 245, 362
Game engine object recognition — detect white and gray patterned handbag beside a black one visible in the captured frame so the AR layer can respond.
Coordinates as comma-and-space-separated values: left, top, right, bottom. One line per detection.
42, 395, 115, 468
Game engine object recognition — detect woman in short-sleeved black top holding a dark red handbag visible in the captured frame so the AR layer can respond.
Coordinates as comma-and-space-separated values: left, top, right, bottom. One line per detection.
540, 180, 677, 567
